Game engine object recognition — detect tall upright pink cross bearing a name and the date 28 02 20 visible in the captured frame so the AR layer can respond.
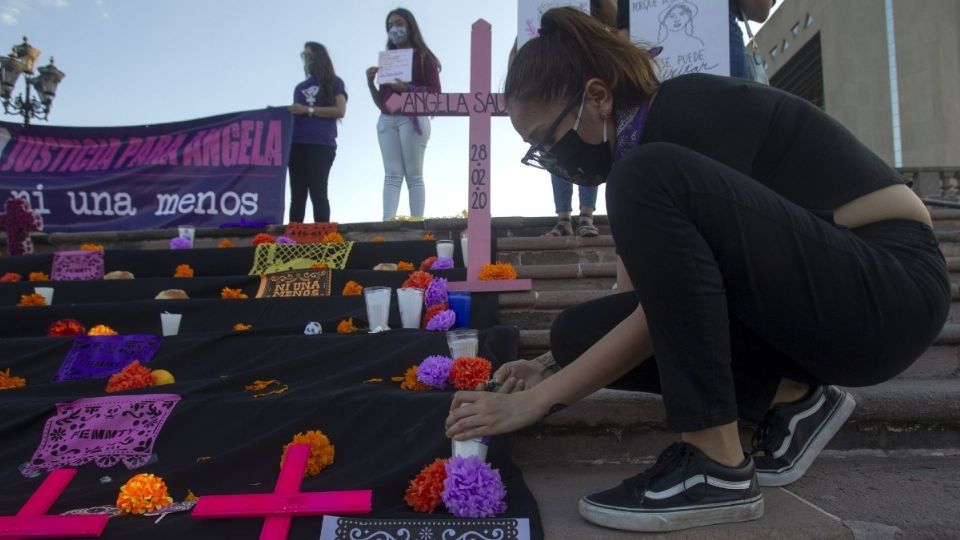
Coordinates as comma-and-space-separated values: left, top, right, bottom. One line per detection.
387, 19, 532, 292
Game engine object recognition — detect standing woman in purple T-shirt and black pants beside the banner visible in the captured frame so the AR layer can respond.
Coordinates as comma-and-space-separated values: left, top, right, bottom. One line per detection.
287, 41, 347, 223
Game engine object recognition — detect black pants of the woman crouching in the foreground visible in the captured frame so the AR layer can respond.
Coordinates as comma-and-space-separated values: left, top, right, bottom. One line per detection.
551, 143, 951, 432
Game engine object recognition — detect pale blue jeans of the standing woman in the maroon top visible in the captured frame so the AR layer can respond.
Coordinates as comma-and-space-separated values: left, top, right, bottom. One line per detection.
377, 114, 430, 221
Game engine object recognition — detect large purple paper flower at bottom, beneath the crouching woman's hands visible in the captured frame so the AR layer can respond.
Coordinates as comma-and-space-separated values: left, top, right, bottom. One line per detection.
443, 456, 507, 518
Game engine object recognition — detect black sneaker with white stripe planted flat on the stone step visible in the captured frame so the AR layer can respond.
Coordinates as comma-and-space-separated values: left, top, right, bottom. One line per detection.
580, 443, 763, 532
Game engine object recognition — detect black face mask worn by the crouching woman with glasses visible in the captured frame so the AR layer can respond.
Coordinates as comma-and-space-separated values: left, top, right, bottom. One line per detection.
521, 89, 613, 186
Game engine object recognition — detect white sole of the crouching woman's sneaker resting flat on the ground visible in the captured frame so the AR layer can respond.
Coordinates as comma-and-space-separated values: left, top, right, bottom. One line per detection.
580, 494, 763, 532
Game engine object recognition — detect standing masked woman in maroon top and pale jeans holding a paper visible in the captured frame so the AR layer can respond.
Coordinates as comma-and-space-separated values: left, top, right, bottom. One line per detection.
367, 8, 440, 221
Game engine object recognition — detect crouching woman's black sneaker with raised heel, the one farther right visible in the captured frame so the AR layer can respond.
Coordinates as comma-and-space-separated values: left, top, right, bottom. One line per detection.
753, 386, 857, 487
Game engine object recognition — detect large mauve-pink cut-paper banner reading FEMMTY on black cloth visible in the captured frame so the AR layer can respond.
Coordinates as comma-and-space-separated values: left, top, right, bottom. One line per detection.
20, 394, 180, 476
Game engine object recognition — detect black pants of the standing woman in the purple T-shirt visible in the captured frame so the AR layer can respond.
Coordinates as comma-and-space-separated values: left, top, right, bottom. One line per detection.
289, 143, 337, 223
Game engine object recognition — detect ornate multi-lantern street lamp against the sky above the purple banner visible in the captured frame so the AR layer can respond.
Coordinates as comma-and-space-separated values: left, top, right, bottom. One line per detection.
0, 36, 66, 125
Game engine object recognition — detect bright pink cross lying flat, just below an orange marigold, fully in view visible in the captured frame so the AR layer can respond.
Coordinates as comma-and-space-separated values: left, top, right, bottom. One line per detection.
190, 444, 373, 540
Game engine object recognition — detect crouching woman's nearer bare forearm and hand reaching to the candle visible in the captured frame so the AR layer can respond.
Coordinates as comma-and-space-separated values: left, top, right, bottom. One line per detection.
446, 307, 653, 440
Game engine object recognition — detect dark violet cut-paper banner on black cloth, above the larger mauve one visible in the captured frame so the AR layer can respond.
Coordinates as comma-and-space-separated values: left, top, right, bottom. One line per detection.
53, 334, 163, 381
